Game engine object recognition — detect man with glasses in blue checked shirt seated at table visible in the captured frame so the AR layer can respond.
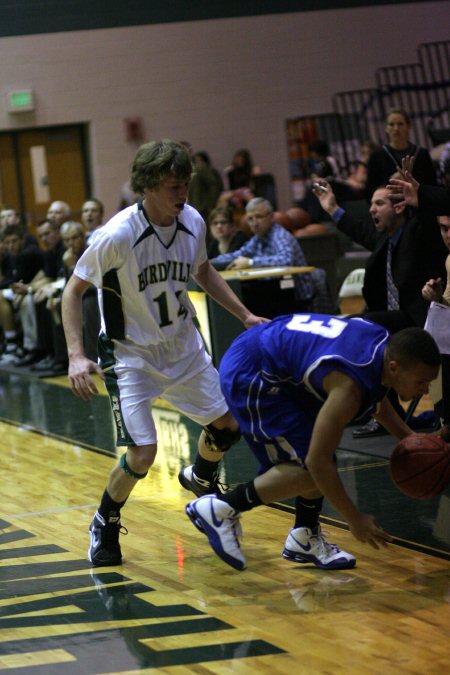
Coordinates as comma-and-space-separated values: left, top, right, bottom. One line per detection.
211, 197, 313, 318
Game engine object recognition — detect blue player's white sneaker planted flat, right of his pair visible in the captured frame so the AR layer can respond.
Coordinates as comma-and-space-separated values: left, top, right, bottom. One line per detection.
283, 527, 356, 570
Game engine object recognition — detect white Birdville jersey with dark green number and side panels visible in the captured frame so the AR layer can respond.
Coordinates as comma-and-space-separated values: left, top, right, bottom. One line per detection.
74, 203, 207, 346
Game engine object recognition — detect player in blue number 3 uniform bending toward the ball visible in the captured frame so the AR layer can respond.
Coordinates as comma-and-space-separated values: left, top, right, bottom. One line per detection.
186, 314, 440, 570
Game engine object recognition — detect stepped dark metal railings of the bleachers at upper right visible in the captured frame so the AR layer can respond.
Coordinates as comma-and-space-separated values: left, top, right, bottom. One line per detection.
287, 41, 450, 180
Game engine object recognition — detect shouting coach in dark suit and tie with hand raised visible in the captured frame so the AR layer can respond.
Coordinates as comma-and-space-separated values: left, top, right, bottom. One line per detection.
315, 180, 448, 437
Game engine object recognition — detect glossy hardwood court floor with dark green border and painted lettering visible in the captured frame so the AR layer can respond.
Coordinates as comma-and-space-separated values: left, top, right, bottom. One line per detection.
0, 372, 450, 675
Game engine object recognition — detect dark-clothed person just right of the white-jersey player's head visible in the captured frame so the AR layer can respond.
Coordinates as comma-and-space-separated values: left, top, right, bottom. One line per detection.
189, 152, 223, 221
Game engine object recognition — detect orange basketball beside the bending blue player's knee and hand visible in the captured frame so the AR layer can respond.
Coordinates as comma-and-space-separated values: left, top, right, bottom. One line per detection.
390, 434, 450, 499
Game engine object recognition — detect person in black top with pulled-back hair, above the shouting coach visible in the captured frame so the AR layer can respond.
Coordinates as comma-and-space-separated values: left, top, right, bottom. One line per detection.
366, 108, 436, 201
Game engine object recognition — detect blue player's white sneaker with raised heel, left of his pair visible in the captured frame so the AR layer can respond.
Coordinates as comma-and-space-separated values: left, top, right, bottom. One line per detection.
186, 495, 246, 570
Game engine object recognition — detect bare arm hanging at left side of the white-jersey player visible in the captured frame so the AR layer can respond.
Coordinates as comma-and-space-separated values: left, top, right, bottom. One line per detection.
61, 274, 105, 401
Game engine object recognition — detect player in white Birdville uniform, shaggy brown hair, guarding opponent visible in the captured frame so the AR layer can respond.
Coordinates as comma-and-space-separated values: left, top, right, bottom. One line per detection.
62, 140, 266, 566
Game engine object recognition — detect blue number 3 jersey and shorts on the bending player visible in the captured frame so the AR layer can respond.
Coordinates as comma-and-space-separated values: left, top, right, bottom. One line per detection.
220, 314, 389, 466
